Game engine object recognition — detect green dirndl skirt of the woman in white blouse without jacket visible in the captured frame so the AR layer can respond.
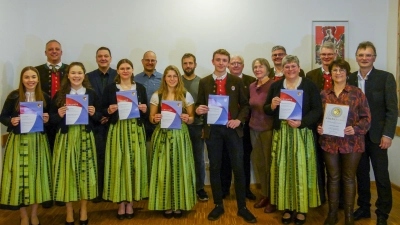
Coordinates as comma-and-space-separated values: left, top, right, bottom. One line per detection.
149, 123, 196, 210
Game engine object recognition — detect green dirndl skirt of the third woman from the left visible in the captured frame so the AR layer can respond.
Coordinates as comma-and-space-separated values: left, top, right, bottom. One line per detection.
103, 119, 149, 202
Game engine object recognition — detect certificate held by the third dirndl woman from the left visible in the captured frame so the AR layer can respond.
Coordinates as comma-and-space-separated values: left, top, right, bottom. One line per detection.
117, 90, 140, 120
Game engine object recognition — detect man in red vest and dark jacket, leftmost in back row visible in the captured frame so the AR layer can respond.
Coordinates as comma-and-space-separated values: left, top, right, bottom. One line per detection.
35, 40, 68, 208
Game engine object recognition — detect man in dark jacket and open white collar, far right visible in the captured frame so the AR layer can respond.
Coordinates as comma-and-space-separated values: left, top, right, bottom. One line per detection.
349, 41, 398, 225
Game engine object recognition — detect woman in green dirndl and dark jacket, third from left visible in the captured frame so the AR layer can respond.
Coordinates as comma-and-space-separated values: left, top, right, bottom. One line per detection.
102, 59, 148, 220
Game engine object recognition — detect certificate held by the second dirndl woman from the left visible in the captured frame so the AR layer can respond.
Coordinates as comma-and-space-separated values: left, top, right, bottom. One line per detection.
65, 94, 89, 125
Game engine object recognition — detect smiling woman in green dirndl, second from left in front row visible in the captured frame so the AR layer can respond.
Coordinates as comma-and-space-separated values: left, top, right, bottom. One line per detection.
50, 62, 102, 225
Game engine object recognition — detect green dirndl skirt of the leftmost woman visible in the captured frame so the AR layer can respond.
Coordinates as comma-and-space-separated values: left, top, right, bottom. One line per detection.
0, 132, 52, 209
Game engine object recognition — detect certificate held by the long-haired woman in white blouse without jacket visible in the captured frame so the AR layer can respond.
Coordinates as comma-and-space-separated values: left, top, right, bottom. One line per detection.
161, 100, 182, 129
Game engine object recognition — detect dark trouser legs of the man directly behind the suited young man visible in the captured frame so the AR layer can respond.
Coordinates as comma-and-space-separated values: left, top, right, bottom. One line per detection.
221, 123, 253, 193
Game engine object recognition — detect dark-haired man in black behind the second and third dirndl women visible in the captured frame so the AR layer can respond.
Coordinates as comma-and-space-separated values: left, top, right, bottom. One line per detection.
86, 47, 117, 203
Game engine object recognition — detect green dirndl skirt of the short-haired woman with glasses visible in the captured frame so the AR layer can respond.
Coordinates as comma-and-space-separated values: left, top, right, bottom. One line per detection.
271, 121, 321, 213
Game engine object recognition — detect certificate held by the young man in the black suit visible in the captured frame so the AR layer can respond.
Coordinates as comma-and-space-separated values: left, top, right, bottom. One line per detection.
207, 95, 229, 125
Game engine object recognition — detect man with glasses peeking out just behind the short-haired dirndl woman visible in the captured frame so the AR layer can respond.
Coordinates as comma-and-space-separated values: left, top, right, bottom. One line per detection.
268, 45, 305, 81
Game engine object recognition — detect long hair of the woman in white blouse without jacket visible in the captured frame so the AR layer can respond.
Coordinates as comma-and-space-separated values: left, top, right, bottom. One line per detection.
157, 65, 186, 108
